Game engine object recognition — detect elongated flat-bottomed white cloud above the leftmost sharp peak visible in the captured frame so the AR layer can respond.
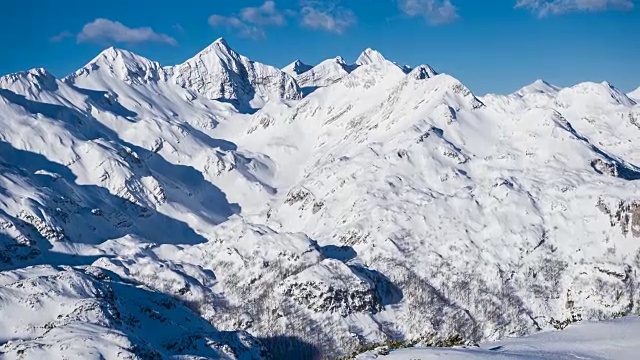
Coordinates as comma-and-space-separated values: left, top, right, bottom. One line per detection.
76, 19, 178, 45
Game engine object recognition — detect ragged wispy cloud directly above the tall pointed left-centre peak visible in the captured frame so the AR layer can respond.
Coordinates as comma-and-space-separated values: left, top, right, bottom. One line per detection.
209, 0, 286, 40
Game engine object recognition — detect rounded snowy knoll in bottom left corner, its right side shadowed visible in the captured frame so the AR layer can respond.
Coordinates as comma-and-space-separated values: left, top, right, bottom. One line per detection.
0, 265, 264, 360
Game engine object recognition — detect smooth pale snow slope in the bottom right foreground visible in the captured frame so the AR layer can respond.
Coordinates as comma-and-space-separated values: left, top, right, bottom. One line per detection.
356, 318, 640, 360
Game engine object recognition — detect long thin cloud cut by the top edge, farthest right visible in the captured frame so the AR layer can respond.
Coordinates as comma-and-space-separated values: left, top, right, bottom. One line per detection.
515, 0, 634, 17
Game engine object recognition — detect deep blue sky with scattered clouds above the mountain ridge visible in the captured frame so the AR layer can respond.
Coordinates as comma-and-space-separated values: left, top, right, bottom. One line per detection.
0, 0, 640, 94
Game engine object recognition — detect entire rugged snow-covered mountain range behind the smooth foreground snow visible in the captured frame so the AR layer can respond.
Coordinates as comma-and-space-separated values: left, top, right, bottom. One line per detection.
0, 40, 640, 359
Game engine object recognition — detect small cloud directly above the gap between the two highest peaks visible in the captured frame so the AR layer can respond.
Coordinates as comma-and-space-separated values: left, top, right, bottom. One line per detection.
300, 1, 357, 34
